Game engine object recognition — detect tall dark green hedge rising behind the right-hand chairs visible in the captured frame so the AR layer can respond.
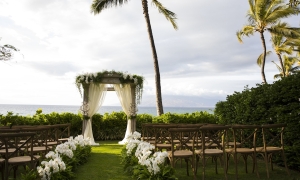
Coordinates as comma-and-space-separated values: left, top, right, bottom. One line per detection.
214, 73, 300, 170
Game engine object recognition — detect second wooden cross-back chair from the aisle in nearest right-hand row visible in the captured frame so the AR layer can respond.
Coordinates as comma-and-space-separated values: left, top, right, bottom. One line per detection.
195, 125, 229, 179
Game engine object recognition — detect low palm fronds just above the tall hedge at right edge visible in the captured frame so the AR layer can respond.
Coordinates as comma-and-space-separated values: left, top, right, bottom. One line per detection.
272, 55, 300, 79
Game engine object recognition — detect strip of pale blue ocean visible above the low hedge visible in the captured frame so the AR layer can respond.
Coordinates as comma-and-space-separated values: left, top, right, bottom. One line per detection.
0, 104, 214, 116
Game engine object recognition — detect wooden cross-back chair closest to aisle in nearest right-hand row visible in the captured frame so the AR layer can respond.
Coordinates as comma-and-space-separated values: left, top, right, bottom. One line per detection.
168, 128, 199, 179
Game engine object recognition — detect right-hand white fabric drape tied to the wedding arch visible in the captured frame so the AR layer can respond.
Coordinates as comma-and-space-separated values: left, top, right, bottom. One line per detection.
114, 84, 132, 144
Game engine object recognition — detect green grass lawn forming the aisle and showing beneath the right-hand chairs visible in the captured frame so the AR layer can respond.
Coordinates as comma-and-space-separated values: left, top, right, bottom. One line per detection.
75, 141, 300, 180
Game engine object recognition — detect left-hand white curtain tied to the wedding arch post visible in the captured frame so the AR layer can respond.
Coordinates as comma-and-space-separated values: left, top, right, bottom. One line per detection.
83, 83, 106, 145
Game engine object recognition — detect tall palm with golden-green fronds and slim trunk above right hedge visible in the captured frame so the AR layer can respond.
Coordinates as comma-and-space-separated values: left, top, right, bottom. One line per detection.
236, 0, 300, 83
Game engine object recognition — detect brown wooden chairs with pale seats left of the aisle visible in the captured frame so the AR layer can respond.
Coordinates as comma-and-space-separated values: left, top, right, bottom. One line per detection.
0, 124, 70, 180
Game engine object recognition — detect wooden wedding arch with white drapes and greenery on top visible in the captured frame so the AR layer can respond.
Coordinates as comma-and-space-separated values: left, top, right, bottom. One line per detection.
76, 71, 144, 145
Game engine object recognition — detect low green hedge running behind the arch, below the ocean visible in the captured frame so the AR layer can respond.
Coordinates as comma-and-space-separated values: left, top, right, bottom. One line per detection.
0, 110, 217, 140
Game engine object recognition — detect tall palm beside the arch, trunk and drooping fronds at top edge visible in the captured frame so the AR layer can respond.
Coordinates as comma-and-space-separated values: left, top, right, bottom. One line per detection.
91, 0, 177, 116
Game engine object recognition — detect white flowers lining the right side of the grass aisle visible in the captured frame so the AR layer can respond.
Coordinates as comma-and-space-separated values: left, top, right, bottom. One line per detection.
126, 132, 168, 175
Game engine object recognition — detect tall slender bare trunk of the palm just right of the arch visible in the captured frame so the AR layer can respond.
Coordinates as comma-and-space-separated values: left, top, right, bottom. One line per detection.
142, 0, 164, 116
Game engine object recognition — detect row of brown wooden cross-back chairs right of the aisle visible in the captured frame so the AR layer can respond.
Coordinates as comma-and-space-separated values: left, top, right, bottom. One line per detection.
142, 124, 289, 179
